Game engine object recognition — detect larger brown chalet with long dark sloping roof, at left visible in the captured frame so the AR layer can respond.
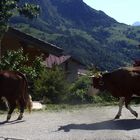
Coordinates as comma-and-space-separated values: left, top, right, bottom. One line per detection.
1, 27, 63, 63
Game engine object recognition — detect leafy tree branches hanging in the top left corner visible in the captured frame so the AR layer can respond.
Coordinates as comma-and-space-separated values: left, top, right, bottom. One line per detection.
0, 0, 39, 36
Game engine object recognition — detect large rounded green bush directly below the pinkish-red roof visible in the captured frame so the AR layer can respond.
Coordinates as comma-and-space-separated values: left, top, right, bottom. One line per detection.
34, 66, 67, 103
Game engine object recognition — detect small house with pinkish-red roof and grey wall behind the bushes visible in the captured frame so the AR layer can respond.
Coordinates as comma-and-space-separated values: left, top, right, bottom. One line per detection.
44, 54, 86, 82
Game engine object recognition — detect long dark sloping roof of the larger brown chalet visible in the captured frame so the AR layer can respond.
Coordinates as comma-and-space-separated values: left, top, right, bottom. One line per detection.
6, 27, 63, 56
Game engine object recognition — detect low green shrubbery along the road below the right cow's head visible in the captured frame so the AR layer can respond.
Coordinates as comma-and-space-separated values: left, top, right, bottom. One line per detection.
68, 72, 117, 103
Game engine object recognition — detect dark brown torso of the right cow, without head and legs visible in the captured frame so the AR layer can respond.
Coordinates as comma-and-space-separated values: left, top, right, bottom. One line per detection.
103, 67, 140, 97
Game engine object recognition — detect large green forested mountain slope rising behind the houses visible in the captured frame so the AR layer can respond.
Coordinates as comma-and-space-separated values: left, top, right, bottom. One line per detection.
11, 0, 140, 70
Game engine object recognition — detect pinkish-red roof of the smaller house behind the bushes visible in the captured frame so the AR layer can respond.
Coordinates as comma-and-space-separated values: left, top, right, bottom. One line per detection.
44, 54, 85, 68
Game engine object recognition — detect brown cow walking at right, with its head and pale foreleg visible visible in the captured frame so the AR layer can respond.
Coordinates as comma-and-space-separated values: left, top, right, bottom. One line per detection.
92, 67, 140, 119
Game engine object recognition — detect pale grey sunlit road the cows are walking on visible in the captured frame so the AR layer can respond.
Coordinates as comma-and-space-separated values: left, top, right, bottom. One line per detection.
0, 106, 140, 140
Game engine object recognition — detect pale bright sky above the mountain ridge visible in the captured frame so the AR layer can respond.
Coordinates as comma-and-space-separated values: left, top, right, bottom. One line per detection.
83, 0, 140, 25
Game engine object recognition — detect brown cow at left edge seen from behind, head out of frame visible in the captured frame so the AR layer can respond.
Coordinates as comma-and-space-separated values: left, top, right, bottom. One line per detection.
0, 71, 32, 121
